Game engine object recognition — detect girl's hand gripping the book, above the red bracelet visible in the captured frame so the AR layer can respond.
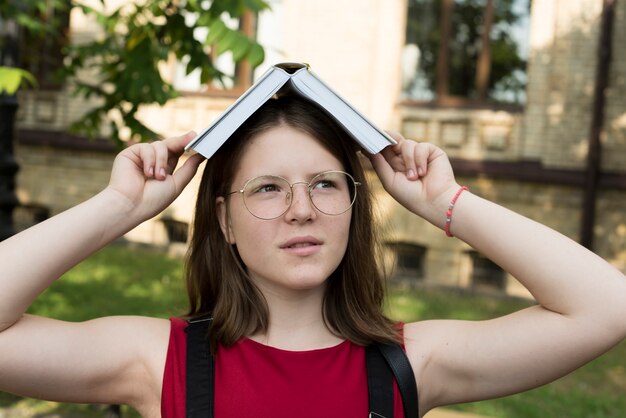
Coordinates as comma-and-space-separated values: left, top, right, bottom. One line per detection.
370, 132, 459, 226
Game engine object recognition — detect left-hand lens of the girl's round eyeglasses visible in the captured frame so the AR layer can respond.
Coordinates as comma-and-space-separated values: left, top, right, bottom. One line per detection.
243, 176, 291, 219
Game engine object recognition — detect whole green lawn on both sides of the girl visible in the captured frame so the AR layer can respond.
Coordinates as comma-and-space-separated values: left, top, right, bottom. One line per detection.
0, 246, 626, 418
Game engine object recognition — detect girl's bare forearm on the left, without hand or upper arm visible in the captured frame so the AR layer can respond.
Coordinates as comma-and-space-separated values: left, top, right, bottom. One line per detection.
0, 189, 135, 330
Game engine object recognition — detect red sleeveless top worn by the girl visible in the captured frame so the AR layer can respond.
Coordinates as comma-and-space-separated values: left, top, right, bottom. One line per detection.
161, 318, 404, 418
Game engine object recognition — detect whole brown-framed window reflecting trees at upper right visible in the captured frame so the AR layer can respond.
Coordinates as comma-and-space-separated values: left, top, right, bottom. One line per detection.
403, 0, 530, 104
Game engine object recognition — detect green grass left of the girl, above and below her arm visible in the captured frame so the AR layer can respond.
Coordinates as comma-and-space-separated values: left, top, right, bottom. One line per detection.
0, 245, 187, 418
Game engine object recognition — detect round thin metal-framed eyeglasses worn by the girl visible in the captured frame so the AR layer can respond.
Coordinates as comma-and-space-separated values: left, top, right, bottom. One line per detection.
227, 171, 361, 220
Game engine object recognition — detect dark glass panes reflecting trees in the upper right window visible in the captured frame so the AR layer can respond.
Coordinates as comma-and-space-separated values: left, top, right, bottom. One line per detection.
407, 0, 530, 102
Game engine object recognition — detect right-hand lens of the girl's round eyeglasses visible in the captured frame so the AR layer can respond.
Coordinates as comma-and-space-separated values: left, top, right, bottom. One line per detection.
311, 171, 356, 215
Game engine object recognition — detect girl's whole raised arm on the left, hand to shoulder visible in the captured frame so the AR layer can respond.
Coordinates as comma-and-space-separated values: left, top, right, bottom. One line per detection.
0, 133, 201, 412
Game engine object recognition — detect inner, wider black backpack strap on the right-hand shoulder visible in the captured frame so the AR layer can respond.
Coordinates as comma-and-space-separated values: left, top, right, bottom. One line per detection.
365, 344, 393, 418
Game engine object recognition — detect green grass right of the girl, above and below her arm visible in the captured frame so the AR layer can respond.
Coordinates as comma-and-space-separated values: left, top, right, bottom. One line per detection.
388, 289, 626, 418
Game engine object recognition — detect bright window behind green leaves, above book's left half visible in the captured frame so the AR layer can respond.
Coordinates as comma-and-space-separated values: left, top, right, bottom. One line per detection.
174, 11, 256, 95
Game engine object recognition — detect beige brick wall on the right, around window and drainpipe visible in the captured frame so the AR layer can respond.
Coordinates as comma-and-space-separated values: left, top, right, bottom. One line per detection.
381, 0, 626, 294
